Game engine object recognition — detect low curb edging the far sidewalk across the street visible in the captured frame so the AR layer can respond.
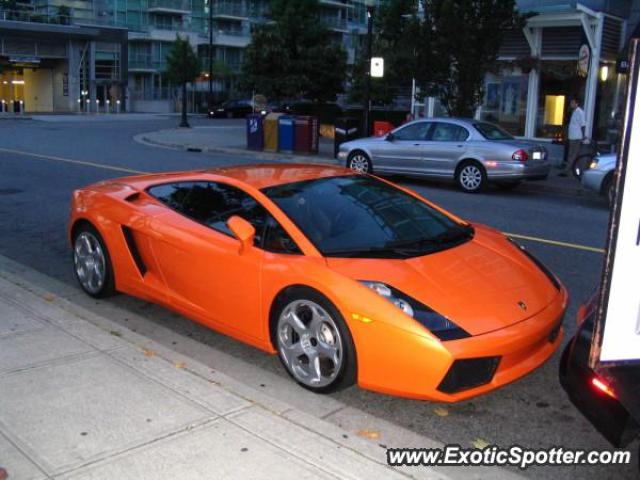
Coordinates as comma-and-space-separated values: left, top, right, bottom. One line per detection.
133, 133, 600, 199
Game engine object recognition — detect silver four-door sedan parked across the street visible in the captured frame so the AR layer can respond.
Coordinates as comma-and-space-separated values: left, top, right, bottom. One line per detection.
338, 118, 551, 192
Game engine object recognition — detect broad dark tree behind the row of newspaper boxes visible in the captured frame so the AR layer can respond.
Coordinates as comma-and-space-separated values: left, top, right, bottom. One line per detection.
240, 0, 346, 101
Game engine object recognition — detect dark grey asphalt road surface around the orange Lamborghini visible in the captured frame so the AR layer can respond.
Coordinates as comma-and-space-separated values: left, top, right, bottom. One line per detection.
0, 117, 637, 480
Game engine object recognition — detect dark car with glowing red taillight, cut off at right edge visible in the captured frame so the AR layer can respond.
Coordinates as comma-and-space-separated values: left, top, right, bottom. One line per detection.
560, 294, 640, 466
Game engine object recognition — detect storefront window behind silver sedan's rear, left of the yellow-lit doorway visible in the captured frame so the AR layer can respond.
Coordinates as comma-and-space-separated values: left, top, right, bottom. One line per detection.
480, 68, 529, 135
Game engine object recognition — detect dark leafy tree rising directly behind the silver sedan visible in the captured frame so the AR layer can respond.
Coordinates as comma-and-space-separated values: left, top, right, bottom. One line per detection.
416, 0, 527, 116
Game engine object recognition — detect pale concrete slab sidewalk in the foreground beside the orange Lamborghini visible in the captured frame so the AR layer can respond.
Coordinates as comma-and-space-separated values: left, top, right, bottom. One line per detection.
0, 269, 440, 480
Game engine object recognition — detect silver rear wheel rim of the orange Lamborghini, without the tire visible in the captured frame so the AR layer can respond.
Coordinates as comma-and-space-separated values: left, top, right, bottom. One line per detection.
73, 231, 107, 294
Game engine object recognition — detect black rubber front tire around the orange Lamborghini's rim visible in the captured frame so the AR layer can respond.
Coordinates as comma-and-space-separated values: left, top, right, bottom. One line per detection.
270, 286, 357, 394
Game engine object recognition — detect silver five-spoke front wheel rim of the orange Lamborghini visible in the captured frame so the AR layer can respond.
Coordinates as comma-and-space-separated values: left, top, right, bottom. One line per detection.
277, 300, 343, 388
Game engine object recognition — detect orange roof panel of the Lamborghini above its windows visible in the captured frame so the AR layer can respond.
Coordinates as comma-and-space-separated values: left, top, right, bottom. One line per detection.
116, 163, 355, 190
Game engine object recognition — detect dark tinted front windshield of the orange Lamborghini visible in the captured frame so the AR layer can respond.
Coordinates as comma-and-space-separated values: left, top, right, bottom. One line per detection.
262, 175, 473, 258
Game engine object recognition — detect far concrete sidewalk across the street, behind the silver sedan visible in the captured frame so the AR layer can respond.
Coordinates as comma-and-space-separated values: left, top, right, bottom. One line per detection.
134, 124, 598, 198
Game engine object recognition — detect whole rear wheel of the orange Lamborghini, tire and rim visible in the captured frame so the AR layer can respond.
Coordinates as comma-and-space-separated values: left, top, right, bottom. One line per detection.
73, 223, 115, 298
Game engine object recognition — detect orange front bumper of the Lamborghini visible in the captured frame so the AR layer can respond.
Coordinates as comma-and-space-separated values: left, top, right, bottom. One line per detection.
358, 288, 568, 402
